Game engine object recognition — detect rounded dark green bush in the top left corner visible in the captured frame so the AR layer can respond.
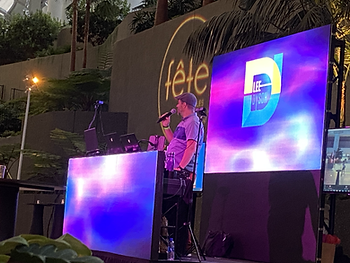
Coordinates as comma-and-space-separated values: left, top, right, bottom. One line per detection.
0, 11, 61, 65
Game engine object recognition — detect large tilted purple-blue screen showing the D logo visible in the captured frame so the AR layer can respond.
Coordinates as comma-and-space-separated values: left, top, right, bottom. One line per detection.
205, 26, 331, 173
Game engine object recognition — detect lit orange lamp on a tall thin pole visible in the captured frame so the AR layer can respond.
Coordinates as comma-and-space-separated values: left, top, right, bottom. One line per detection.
17, 75, 39, 180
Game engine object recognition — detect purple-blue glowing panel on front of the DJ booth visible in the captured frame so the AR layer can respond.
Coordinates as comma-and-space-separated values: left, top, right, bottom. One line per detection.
63, 151, 158, 259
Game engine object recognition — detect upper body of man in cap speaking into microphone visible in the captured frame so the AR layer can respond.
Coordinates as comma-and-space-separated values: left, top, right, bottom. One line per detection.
162, 93, 204, 177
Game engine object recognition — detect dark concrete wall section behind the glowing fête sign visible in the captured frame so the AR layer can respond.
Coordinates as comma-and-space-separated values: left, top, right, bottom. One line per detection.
109, 1, 232, 142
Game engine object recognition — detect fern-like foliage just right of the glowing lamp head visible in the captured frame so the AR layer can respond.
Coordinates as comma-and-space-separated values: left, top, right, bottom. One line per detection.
30, 69, 110, 114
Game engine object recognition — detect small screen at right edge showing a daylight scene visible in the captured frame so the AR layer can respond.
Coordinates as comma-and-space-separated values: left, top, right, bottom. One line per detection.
323, 128, 350, 193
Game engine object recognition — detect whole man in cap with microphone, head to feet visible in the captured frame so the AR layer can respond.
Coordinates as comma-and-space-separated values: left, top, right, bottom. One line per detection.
162, 93, 204, 256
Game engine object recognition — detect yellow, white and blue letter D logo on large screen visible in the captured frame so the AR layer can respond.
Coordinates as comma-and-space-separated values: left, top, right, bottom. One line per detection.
242, 53, 283, 127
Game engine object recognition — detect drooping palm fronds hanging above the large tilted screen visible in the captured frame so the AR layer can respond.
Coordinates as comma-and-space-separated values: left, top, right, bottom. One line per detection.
184, 0, 350, 68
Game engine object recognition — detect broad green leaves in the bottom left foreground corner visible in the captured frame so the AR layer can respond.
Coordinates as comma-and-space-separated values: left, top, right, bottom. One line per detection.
0, 234, 103, 263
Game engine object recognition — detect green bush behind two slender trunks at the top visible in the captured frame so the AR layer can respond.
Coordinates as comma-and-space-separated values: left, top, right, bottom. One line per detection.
66, 0, 130, 46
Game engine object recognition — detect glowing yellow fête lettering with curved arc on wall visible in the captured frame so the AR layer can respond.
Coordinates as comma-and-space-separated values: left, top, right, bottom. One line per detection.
158, 14, 210, 129
